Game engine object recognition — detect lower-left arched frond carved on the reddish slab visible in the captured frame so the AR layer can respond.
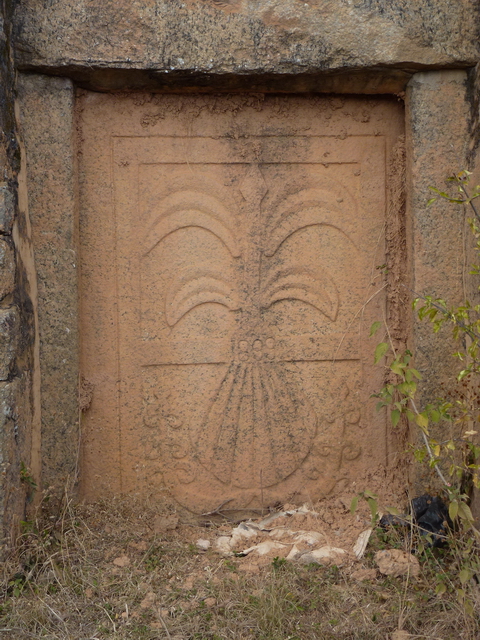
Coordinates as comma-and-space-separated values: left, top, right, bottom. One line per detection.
165, 276, 240, 327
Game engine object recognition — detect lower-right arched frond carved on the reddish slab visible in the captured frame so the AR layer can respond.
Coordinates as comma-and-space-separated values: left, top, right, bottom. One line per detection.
261, 268, 340, 322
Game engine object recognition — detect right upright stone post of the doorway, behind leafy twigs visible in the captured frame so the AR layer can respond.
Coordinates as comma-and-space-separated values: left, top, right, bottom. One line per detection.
406, 71, 470, 490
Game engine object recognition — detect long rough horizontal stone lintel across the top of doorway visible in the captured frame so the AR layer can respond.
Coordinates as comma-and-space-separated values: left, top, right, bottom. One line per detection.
15, 0, 479, 92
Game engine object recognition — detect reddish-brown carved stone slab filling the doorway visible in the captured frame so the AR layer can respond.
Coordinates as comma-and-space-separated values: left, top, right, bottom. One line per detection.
79, 93, 402, 512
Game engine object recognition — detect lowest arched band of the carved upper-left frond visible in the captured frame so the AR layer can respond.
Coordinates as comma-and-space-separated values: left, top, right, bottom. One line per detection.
144, 210, 241, 258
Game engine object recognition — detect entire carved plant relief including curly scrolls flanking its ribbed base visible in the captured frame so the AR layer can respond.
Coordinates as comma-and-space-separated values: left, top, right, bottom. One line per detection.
140, 164, 361, 502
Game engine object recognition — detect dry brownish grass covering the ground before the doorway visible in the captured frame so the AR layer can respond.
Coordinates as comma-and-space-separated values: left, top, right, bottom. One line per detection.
0, 500, 480, 640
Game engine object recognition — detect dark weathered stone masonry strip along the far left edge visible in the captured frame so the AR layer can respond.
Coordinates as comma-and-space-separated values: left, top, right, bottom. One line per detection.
0, 2, 38, 555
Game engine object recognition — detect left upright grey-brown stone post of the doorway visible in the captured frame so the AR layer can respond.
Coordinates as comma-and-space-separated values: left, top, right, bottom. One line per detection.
18, 75, 79, 492
